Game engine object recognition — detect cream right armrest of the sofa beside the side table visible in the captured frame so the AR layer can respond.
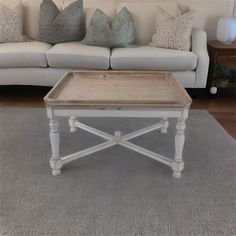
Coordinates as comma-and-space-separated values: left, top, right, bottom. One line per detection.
192, 28, 209, 88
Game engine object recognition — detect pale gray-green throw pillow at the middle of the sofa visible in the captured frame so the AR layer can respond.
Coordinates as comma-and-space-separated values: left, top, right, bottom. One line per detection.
82, 7, 137, 48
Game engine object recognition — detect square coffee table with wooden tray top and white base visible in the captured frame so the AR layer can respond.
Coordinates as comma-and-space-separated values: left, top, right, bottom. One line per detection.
44, 71, 192, 178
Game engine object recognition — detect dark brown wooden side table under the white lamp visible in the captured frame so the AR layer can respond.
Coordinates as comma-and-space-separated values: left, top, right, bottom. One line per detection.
207, 40, 236, 94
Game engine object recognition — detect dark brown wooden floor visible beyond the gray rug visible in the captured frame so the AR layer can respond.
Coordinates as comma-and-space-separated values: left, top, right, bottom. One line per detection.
0, 86, 236, 139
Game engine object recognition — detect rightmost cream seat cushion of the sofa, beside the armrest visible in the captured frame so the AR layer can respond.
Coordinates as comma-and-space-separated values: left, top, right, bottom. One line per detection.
111, 46, 197, 71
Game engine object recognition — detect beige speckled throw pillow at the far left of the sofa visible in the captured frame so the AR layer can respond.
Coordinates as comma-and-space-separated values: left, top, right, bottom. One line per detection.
0, 3, 23, 43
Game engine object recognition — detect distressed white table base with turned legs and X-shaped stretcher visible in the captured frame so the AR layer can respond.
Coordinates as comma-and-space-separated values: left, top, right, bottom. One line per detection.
47, 107, 188, 178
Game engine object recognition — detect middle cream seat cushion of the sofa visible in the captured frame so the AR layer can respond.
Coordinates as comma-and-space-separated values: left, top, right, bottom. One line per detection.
47, 42, 110, 69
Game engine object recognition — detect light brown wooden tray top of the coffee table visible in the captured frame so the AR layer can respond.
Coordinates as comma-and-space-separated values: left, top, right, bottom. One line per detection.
44, 71, 192, 108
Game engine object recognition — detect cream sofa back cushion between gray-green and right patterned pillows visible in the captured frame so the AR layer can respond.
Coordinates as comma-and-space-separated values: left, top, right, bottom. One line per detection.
116, 1, 178, 45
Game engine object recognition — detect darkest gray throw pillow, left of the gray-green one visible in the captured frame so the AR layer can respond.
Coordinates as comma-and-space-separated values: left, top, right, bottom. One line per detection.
39, 0, 84, 44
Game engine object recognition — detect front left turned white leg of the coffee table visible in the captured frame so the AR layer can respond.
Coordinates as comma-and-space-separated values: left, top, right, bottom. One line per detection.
49, 118, 62, 175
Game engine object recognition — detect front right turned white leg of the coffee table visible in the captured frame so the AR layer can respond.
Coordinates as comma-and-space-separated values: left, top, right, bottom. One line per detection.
172, 117, 185, 178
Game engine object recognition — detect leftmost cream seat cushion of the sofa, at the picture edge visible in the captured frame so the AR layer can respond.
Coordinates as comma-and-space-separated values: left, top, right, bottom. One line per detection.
0, 42, 52, 68
